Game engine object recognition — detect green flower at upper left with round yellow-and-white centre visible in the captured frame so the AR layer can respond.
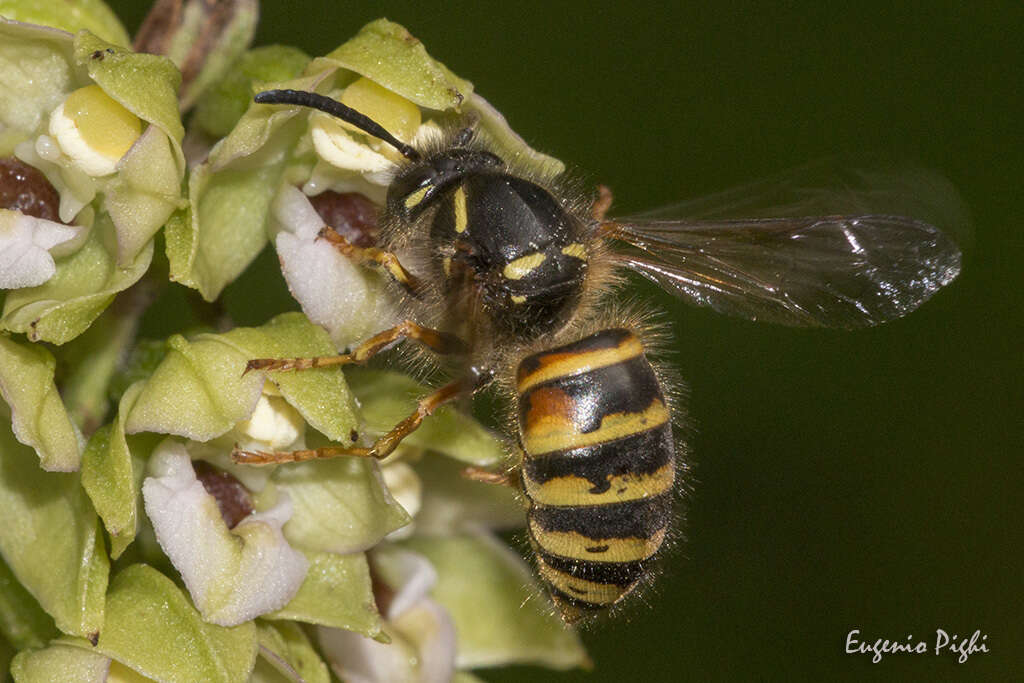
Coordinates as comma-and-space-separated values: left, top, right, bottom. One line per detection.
0, 17, 184, 344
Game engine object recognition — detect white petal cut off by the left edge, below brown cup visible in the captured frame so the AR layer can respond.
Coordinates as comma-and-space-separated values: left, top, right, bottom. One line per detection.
0, 209, 80, 290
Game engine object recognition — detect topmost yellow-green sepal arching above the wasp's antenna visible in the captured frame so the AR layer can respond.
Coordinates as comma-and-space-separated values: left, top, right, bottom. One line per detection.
317, 19, 473, 111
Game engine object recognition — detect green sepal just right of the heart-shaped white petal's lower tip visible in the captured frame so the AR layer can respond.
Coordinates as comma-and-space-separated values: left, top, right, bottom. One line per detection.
263, 552, 381, 638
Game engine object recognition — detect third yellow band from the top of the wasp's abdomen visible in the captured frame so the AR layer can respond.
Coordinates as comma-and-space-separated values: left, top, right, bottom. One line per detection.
523, 464, 676, 507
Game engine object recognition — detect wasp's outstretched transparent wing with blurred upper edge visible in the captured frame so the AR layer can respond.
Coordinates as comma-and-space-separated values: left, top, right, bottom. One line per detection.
601, 163, 969, 328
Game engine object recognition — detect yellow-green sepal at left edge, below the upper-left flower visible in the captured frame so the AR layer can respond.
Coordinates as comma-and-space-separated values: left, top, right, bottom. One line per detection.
0, 335, 83, 472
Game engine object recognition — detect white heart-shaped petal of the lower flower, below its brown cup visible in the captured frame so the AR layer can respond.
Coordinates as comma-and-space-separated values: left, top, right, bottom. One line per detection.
142, 439, 308, 626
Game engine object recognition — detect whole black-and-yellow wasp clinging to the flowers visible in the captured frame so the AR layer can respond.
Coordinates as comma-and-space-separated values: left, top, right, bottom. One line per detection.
233, 90, 961, 623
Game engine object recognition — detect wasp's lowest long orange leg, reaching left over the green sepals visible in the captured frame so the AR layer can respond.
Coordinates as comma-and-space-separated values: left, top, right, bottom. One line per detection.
231, 373, 489, 465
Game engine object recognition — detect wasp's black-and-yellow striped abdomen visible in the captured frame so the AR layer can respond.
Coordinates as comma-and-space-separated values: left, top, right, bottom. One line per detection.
516, 330, 675, 622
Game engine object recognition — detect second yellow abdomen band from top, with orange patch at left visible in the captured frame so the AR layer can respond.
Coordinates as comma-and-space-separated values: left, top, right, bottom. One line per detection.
522, 394, 670, 456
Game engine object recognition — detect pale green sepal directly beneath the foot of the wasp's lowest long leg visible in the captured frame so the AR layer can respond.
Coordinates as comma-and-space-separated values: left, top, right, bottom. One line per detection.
272, 458, 410, 554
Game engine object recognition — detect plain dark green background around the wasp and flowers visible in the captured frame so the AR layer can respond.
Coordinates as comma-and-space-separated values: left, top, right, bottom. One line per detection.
116, 0, 1024, 683
